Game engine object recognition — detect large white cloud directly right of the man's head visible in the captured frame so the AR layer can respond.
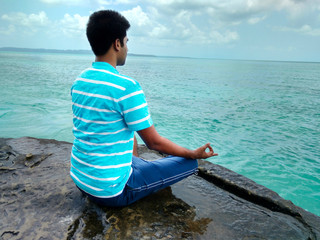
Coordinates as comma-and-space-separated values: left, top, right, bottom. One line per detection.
121, 3, 239, 44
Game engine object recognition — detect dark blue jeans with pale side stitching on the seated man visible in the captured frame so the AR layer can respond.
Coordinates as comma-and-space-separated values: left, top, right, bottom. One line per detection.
80, 156, 198, 207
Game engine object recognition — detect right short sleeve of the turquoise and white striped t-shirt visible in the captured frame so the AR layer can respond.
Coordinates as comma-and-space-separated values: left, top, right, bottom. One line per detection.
119, 83, 153, 131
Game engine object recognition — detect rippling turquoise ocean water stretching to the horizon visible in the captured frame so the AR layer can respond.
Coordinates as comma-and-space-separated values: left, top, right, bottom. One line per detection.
0, 52, 320, 216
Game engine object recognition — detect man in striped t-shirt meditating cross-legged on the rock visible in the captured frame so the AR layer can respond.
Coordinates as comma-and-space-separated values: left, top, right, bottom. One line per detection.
70, 10, 217, 207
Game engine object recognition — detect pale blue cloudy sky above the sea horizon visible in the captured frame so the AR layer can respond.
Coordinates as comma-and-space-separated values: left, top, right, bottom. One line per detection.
0, 0, 320, 62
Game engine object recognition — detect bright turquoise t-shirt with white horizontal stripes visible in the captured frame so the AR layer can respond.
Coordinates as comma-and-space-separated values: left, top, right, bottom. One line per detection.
70, 62, 152, 198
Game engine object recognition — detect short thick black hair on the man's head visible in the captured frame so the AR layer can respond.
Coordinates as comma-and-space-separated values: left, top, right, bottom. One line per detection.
87, 10, 130, 56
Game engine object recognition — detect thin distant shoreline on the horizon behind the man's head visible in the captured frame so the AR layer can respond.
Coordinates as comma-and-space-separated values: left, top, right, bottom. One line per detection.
0, 47, 156, 57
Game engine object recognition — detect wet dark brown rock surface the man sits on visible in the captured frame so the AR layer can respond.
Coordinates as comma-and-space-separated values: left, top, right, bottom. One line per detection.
0, 137, 320, 240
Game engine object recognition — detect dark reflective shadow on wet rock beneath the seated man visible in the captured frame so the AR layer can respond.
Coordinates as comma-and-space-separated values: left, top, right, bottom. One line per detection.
67, 187, 212, 240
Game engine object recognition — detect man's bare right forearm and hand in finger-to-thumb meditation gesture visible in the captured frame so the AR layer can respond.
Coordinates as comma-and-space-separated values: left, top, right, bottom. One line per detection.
138, 125, 218, 159
